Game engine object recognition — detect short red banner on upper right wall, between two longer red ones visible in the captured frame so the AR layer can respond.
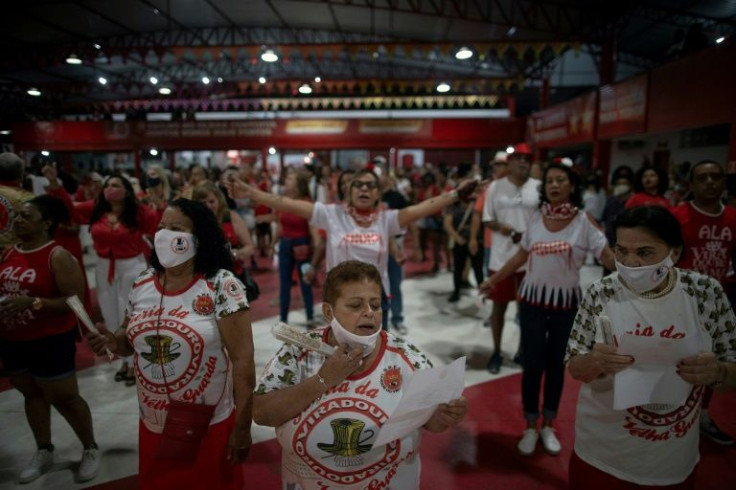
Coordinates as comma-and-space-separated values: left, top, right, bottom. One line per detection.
598, 74, 648, 138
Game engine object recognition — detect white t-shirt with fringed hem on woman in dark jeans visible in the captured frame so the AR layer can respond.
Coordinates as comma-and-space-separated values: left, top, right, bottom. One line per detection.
519, 211, 607, 309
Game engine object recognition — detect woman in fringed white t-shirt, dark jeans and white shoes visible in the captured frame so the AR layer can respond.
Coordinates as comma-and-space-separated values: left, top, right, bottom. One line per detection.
481, 163, 613, 456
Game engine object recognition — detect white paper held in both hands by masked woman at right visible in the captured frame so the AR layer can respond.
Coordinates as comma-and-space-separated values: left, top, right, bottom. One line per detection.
613, 334, 698, 410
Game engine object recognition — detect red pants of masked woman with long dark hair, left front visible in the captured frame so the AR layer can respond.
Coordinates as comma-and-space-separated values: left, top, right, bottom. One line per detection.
138, 412, 244, 490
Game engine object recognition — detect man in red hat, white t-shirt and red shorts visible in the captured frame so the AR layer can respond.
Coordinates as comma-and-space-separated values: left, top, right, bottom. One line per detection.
483, 143, 540, 374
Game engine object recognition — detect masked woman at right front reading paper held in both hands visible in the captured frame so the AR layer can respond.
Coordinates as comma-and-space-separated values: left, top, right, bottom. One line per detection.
567, 206, 736, 490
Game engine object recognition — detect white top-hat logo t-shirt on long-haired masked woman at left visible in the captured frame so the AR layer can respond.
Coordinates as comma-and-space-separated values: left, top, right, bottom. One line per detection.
126, 268, 248, 433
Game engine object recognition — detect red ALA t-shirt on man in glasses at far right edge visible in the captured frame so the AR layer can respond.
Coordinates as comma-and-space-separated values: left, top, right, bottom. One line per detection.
671, 202, 736, 282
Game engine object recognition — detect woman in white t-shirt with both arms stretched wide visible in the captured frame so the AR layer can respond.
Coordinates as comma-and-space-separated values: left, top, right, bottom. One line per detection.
228, 169, 478, 329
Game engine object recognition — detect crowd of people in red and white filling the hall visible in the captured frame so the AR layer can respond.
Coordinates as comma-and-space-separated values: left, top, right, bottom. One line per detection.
0, 147, 736, 489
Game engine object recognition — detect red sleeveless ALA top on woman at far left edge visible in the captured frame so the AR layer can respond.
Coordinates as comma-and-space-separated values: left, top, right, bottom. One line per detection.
0, 241, 77, 342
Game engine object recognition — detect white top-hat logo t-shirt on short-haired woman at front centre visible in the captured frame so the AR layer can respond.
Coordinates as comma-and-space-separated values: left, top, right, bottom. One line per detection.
256, 327, 432, 490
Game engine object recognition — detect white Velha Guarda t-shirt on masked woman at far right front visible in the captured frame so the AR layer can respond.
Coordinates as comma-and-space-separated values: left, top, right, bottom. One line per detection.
566, 269, 736, 485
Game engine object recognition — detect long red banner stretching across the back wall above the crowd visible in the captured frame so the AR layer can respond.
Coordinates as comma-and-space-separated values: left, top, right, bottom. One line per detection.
8, 119, 523, 151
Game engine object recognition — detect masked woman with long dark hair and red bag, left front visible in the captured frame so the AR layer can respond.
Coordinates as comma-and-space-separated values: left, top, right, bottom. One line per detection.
87, 199, 255, 490
